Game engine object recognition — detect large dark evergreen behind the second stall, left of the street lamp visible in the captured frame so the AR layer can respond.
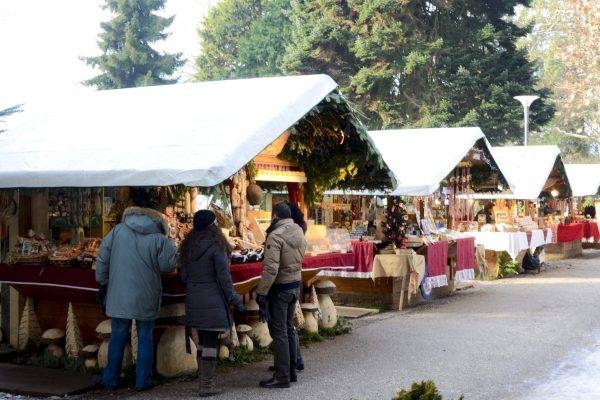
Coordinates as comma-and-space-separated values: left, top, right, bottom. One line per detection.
285, 0, 553, 144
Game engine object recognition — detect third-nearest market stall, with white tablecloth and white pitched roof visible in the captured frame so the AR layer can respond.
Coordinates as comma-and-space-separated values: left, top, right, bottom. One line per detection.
466, 146, 581, 276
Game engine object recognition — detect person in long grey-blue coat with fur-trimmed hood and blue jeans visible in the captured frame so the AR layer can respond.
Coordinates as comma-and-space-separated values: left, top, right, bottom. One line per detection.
96, 203, 177, 391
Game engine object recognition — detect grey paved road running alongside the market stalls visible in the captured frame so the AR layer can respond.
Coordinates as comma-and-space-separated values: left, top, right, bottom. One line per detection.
79, 252, 600, 400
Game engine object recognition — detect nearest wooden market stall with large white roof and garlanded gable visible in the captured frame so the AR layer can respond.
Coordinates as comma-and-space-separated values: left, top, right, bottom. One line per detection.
0, 75, 395, 360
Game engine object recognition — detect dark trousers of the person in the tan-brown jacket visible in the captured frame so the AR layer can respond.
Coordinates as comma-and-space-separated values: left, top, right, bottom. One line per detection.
269, 289, 298, 380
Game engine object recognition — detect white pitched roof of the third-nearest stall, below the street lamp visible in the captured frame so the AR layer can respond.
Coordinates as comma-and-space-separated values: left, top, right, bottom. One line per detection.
470, 145, 571, 200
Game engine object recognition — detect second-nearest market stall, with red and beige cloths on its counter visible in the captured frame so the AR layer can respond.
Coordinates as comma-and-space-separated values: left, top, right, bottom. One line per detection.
314, 127, 509, 308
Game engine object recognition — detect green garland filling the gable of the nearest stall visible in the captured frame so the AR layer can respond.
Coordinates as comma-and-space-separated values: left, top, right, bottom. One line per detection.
279, 90, 395, 204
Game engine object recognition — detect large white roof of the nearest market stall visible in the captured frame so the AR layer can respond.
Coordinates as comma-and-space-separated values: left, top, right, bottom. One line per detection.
0, 75, 337, 188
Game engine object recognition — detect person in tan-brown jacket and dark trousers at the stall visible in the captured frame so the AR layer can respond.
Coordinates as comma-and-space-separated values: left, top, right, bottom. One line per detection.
256, 203, 306, 388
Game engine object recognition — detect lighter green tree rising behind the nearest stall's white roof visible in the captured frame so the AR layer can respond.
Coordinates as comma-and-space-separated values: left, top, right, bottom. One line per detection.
196, 0, 291, 81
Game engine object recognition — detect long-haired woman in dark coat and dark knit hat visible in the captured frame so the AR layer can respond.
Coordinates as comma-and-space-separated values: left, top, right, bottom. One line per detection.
179, 210, 245, 397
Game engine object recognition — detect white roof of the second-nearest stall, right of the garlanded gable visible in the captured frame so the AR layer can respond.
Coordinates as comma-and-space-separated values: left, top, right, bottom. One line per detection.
369, 127, 510, 196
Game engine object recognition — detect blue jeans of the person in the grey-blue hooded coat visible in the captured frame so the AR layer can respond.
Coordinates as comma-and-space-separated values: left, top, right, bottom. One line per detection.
102, 318, 154, 389
